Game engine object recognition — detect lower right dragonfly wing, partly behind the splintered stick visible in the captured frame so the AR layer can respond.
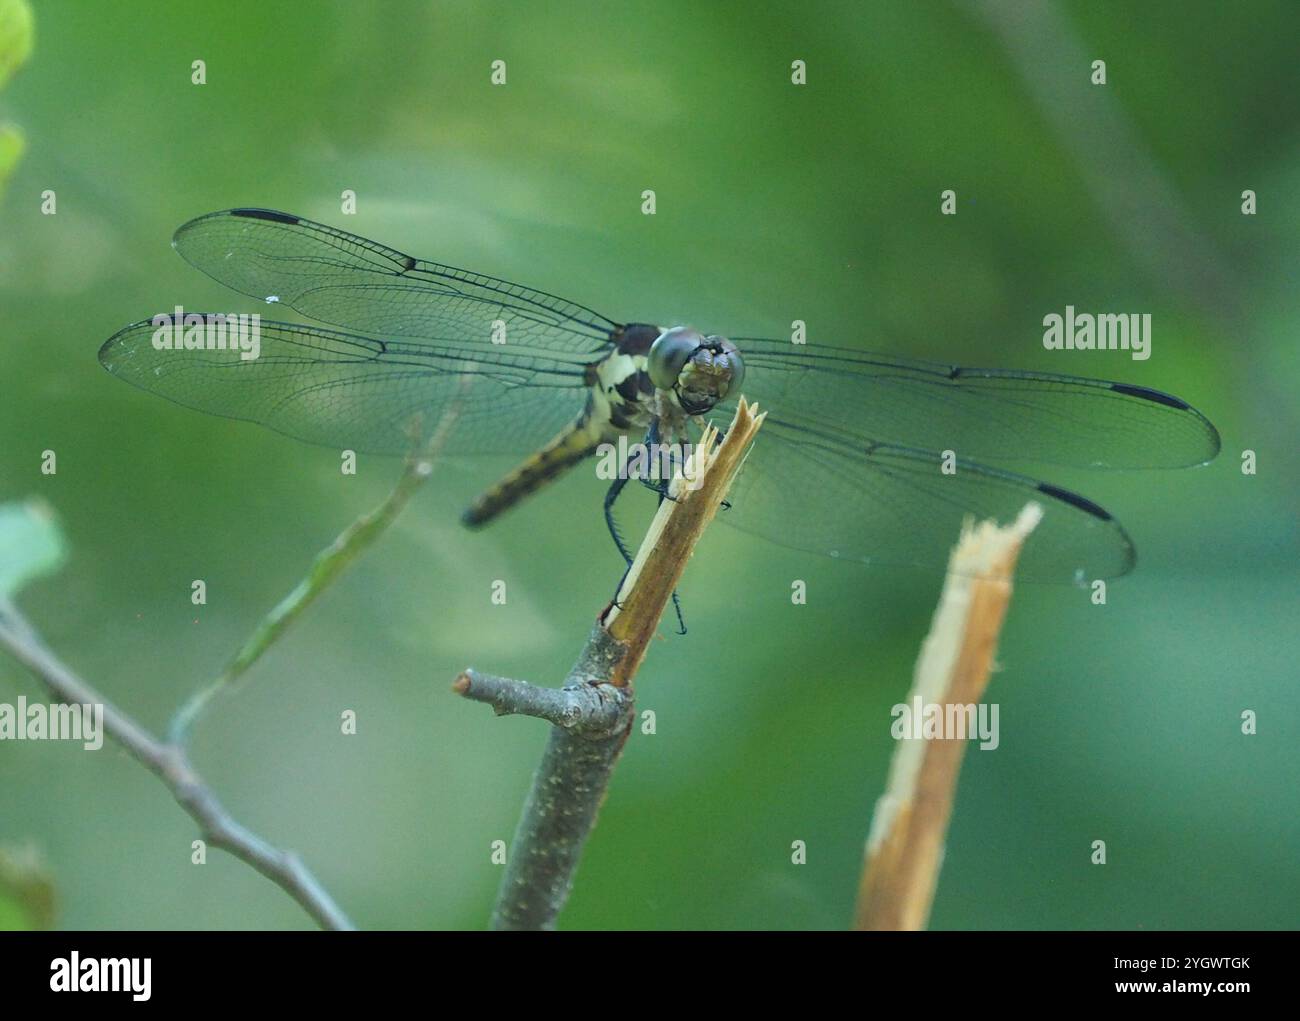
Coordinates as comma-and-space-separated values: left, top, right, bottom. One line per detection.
719, 416, 1135, 583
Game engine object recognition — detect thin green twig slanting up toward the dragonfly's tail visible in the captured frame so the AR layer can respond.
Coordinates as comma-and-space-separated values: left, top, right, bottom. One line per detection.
168, 404, 459, 745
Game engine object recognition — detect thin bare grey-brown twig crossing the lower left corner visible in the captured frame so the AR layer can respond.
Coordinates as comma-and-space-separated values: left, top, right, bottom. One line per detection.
0, 605, 352, 930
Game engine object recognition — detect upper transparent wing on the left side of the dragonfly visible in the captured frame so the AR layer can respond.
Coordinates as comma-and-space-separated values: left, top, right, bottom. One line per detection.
172, 209, 619, 354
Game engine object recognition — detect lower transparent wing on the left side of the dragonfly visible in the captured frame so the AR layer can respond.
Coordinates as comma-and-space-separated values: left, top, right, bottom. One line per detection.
99, 314, 586, 454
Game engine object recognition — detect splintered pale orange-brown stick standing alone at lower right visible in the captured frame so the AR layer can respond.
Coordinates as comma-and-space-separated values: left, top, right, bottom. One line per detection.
855, 503, 1043, 930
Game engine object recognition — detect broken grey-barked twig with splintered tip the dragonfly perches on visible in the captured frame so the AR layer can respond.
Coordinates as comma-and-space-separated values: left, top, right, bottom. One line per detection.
452, 399, 763, 929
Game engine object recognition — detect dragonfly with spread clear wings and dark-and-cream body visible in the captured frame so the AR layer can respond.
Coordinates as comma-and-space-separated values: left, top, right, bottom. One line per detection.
99, 208, 1219, 584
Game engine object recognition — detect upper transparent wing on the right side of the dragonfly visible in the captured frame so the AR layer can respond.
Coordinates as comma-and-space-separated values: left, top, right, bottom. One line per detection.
733, 338, 1219, 468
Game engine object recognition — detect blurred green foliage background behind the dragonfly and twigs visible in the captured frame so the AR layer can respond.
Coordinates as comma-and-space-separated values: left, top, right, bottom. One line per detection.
0, 0, 1300, 929
